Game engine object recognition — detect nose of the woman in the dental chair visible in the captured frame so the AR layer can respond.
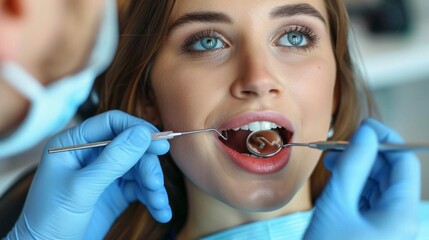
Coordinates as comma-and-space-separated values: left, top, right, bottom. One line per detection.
231, 50, 283, 99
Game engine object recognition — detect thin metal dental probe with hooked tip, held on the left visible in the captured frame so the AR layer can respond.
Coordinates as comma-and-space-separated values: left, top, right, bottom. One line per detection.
48, 128, 228, 153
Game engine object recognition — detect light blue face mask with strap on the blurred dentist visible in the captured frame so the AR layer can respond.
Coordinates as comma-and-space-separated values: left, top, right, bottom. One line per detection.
0, 0, 119, 159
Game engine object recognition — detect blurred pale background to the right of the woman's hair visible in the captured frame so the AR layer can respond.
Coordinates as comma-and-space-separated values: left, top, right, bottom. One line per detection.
352, 0, 429, 200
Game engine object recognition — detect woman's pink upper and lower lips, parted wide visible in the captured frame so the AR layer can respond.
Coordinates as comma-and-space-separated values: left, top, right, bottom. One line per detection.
218, 112, 293, 174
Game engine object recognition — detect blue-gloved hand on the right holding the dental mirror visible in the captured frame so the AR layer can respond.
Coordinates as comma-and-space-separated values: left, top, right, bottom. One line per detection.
305, 119, 420, 240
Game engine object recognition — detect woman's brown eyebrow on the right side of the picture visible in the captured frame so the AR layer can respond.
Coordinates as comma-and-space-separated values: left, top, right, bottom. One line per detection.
270, 3, 327, 25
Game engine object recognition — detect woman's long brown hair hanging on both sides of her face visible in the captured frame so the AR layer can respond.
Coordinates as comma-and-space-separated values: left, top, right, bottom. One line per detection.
97, 0, 373, 239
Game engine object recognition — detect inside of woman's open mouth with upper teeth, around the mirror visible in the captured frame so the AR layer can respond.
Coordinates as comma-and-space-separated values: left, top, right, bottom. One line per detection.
219, 121, 293, 158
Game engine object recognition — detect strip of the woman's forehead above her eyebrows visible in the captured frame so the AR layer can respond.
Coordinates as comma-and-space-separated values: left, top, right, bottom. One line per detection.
171, 0, 328, 21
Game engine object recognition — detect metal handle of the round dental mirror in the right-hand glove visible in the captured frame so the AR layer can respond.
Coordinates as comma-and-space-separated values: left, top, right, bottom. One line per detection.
283, 141, 429, 151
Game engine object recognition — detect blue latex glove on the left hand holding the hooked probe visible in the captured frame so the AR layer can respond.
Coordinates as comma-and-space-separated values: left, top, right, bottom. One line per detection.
8, 111, 172, 239
